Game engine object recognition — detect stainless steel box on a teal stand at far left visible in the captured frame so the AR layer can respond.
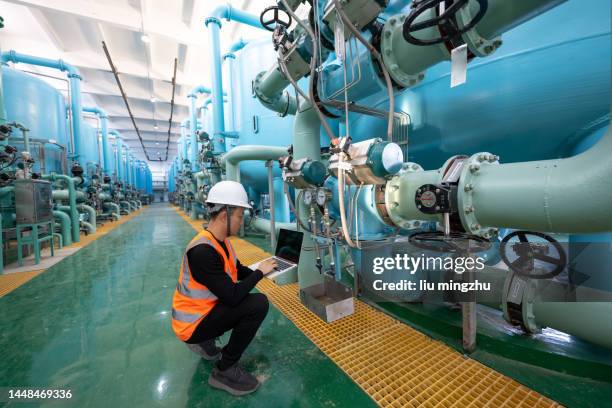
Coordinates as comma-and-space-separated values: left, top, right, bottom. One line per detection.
15, 180, 53, 224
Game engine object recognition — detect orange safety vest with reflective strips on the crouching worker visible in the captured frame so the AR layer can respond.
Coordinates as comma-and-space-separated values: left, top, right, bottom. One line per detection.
172, 230, 238, 341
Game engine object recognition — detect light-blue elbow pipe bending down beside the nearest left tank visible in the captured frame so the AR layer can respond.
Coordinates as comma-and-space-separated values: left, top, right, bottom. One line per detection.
0, 50, 83, 161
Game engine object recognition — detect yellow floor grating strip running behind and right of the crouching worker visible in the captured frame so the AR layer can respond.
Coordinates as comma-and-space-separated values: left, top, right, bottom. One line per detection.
175, 207, 560, 408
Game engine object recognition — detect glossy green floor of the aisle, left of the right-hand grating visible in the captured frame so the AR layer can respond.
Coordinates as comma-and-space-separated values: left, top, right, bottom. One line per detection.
0, 204, 375, 408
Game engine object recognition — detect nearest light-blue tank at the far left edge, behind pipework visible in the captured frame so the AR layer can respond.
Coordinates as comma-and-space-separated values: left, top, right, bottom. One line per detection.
1, 67, 70, 173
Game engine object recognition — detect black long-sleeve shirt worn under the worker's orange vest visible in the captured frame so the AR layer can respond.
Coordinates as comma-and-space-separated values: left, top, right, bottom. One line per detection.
187, 233, 263, 307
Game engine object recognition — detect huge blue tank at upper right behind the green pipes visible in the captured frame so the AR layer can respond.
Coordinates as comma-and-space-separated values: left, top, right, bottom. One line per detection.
350, 0, 612, 169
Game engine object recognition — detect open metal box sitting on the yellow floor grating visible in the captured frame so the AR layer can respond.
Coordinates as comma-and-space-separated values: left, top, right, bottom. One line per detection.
300, 275, 355, 323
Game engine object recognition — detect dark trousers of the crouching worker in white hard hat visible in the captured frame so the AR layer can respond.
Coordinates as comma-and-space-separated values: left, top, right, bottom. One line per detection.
187, 293, 269, 370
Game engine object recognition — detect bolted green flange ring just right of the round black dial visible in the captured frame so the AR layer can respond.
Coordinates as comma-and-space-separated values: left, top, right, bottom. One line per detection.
457, 152, 499, 239
